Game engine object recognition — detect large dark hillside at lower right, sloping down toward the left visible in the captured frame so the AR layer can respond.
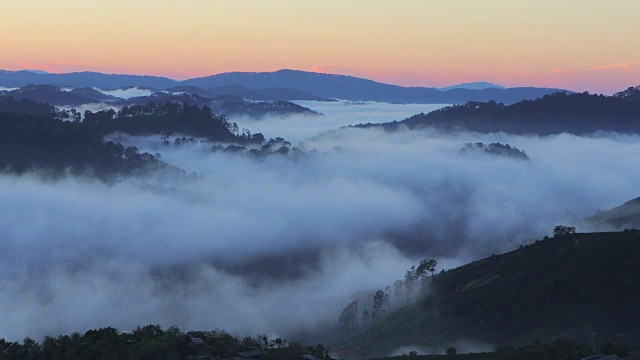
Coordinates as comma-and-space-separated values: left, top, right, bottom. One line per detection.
343, 231, 640, 353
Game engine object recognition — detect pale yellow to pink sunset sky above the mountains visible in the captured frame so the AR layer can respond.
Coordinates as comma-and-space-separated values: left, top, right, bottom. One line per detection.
0, 0, 640, 94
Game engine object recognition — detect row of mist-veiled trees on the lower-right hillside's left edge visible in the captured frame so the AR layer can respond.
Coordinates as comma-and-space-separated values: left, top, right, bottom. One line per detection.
338, 259, 438, 337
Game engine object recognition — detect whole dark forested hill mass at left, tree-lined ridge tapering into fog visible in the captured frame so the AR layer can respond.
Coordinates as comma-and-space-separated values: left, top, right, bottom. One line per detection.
0, 97, 300, 177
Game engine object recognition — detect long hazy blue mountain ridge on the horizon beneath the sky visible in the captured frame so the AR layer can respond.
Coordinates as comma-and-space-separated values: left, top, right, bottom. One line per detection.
0, 69, 561, 104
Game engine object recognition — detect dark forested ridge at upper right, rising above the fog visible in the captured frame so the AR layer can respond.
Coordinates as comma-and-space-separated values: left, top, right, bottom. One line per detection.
359, 89, 640, 135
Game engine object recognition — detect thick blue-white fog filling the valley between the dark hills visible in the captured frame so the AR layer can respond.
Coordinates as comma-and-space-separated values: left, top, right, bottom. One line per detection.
0, 102, 640, 340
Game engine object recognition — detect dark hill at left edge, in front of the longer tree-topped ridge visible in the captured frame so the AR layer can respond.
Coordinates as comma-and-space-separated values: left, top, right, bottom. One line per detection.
0, 112, 166, 180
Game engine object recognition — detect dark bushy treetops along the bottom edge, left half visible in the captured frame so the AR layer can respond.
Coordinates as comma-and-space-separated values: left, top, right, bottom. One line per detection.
0, 325, 336, 360
